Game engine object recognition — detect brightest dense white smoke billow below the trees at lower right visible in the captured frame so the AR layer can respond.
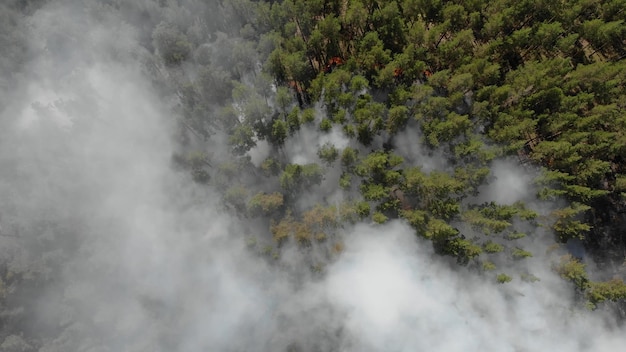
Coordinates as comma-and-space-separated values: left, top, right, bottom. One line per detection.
324, 222, 624, 351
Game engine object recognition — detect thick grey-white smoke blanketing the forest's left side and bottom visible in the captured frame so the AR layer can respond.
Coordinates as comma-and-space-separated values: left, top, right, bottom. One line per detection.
0, 1, 626, 352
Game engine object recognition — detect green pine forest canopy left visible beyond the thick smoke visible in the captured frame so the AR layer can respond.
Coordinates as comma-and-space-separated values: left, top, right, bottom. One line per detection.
80, 0, 626, 316
